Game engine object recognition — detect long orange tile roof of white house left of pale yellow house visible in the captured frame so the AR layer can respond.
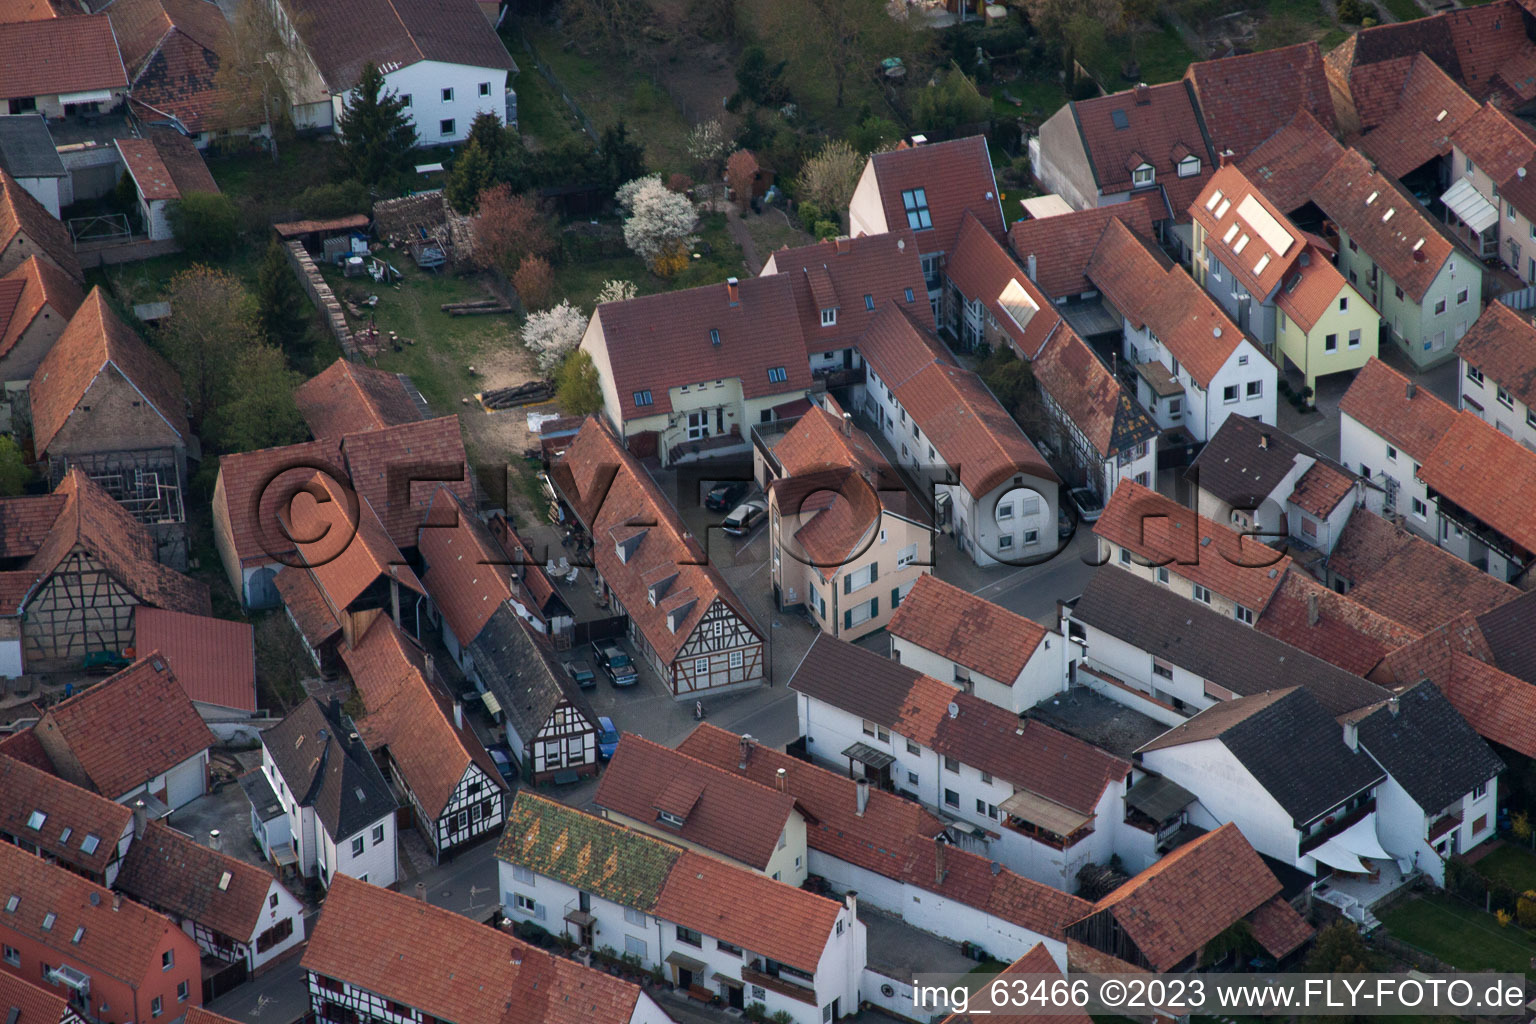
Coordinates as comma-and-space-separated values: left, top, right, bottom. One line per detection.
1087, 221, 1243, 387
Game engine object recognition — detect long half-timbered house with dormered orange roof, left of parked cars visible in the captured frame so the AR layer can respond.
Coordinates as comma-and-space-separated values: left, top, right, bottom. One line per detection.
550, 419, 765, 700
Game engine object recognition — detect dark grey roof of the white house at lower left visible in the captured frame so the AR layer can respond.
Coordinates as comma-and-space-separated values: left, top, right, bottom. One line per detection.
261, 697, 398, 843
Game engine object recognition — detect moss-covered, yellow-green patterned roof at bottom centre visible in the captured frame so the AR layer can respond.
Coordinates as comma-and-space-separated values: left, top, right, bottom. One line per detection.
496, 792, 682, 910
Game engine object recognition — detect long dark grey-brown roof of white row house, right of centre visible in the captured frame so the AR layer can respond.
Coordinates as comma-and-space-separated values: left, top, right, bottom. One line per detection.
1072, 565, 1387, 714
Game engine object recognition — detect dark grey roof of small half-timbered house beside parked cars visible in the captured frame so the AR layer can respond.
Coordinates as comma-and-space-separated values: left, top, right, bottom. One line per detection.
468, 602, 598, 760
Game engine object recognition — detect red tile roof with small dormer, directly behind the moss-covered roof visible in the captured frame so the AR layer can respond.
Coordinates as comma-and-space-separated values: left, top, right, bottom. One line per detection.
593, 732, 796, 870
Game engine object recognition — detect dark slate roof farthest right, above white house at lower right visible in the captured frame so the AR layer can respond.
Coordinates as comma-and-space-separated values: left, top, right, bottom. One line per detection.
1356, 682, 1504, 814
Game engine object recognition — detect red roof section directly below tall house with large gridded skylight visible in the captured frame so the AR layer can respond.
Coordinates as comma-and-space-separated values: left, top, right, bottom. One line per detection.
763, 227, 928, 355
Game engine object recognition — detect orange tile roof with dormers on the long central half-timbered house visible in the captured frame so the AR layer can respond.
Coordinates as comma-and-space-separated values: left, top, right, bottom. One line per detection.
551, 417, 764, 665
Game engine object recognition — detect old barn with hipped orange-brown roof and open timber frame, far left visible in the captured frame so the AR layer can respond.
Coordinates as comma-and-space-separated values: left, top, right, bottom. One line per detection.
28, 289, 192, 568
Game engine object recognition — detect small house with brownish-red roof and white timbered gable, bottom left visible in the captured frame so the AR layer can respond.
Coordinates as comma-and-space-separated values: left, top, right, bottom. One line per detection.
117, 821, 304, 981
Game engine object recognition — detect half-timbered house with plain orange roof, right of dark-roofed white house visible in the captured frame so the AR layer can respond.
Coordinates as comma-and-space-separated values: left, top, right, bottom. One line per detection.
343, 616, 505, 860
